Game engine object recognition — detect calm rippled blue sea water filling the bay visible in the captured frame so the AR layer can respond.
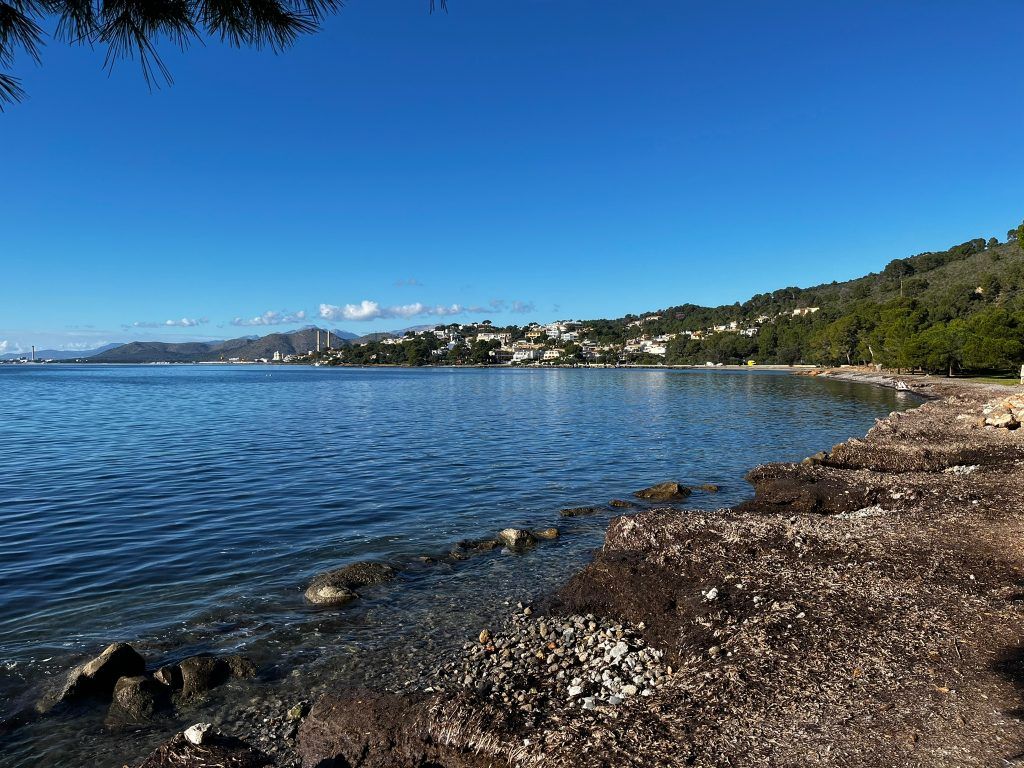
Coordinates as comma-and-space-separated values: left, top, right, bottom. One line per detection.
0, 366, 913, 767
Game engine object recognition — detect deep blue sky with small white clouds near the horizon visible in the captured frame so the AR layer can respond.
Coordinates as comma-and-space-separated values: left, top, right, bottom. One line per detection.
0, 0, 1024, 351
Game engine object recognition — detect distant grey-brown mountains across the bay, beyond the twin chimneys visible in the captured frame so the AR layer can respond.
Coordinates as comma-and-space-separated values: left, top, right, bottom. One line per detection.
86, 327, 382, 362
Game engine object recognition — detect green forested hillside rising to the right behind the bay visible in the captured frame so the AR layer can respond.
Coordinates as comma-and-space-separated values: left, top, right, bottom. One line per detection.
622, 224, 1024, 373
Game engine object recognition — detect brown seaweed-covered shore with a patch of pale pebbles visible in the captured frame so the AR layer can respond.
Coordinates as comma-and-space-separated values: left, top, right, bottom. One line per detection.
32, 372, 1024, 768
